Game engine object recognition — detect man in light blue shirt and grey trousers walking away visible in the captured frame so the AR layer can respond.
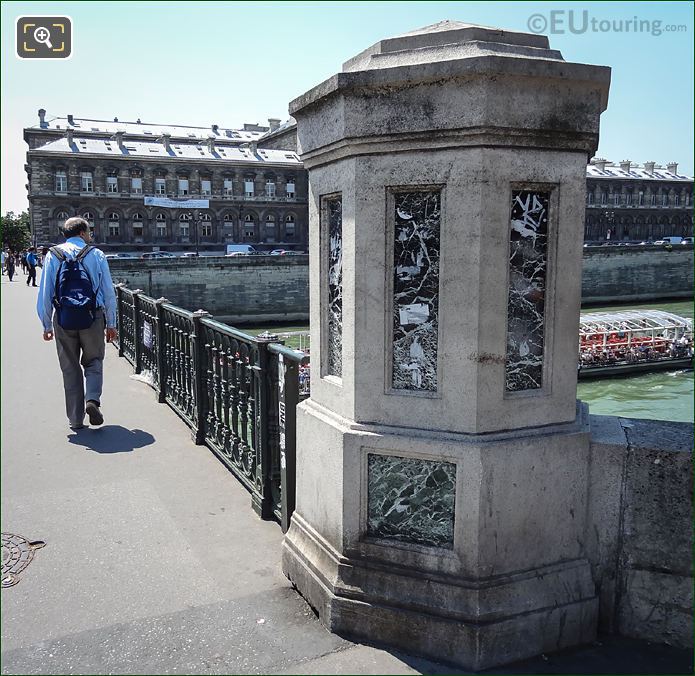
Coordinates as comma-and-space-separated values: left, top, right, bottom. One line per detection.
36, 217, 116, 430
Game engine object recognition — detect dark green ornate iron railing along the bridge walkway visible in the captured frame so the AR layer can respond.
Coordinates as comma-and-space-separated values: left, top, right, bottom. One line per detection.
115, 284, 309, 532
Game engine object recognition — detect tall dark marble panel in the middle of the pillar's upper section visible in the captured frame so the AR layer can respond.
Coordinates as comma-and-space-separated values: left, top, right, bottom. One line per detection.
391, 190, 441, 392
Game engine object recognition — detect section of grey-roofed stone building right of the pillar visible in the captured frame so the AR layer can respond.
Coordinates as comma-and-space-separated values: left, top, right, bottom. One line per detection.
584, 158, 693, 242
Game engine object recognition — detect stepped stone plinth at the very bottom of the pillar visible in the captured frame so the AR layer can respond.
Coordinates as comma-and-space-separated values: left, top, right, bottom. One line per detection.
282, 512, 598, 670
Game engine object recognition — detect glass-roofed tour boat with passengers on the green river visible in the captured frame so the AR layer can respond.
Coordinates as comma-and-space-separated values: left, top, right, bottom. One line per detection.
578, 310, 693, 378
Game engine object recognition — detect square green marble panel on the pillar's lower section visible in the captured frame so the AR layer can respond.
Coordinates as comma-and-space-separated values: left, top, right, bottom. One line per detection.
367, 453, 456, 549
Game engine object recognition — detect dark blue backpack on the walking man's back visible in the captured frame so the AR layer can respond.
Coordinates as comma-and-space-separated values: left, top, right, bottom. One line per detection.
50, 246, 97, 331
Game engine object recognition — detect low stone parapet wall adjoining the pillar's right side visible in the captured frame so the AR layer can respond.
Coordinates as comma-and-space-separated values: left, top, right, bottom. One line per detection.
587, 416, 693, 648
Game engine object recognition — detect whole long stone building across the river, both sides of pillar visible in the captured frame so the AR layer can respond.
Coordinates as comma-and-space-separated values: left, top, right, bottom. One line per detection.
24, 109, 693, 251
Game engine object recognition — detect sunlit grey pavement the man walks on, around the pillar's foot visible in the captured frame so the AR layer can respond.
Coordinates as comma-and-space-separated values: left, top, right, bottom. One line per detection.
1, 275, 692, 674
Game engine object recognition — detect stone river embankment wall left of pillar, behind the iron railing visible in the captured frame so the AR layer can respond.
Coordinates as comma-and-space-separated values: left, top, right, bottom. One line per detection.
109, 255, 309, 324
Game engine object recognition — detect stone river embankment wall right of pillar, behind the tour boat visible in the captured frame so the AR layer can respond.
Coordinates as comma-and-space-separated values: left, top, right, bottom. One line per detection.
582, 244, 693, 304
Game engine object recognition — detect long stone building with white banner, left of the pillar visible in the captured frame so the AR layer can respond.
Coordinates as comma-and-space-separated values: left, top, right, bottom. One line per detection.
24, 109, 308, 251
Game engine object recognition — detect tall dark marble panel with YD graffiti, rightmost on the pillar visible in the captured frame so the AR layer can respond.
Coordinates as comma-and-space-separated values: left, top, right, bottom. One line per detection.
505, 190, 550, 392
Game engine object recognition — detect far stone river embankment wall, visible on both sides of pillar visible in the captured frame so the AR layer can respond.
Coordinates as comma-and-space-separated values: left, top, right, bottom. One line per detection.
109, 246, 693, 323
